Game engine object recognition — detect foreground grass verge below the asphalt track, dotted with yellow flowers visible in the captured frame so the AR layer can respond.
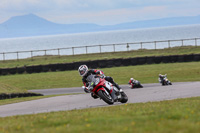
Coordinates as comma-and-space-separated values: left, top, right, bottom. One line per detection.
0, 97, 200, 133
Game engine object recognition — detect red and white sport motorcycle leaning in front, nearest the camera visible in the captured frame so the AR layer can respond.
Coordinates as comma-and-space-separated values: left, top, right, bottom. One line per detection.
83, 75, 128, 104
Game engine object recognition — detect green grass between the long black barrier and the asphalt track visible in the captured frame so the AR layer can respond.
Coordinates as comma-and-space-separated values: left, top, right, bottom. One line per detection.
0, 62, 200, 92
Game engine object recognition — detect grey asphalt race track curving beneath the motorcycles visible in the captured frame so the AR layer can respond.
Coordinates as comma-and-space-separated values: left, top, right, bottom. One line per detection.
0, 82, 200, 117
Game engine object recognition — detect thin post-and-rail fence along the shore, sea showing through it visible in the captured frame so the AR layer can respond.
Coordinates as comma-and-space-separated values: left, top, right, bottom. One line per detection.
0, 38, 200, 61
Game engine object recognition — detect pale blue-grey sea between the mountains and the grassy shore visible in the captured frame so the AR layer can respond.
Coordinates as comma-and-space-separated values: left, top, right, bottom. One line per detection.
0, 24, 200, 60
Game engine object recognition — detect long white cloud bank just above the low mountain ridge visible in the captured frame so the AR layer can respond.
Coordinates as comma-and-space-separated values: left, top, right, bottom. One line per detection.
44, 6, 170, 25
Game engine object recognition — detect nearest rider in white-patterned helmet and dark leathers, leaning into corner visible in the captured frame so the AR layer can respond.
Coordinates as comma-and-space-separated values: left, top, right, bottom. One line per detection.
78, 65, 123, 99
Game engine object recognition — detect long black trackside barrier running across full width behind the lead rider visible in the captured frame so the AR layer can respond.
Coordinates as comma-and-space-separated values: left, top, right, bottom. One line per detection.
0, 54, 200, 75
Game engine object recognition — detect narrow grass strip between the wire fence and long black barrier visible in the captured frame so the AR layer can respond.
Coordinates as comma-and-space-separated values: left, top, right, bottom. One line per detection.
0, 46, 200, 68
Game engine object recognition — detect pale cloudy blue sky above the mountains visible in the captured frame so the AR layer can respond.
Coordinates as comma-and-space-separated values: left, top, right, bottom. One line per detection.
0, 0, 200, 25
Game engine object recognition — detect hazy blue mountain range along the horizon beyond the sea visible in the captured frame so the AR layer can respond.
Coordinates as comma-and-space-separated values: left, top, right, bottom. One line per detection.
0, 14, 200, 38
